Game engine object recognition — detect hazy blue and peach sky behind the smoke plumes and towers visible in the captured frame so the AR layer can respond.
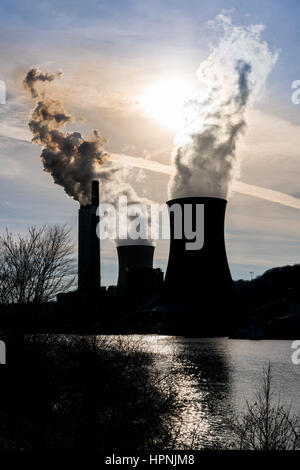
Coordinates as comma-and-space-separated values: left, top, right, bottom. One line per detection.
0, 0, 300, 285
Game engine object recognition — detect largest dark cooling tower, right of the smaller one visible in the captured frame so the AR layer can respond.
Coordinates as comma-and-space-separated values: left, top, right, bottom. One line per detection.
163, 197, 234, 333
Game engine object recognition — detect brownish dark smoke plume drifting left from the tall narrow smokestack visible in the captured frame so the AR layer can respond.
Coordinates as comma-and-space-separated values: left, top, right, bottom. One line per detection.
23, 68, 108, 204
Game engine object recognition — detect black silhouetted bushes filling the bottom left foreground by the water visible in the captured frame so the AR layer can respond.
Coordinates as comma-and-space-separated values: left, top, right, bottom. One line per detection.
0, 335, 179, 452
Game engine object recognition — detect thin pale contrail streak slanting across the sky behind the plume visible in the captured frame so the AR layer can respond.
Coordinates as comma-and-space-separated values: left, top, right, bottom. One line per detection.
110, 153, 300, 210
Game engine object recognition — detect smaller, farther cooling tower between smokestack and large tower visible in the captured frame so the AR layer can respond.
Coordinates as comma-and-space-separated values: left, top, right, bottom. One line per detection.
117, 245, 154, 290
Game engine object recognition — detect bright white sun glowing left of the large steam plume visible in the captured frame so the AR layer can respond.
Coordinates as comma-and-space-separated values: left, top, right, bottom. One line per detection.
140, 77, 195, 130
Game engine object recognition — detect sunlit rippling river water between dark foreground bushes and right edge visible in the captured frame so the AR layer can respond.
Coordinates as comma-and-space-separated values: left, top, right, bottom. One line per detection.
143, 335, 300, 448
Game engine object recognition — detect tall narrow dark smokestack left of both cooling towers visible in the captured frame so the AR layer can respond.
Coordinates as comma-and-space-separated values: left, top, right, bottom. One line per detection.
78, 181, 100, 292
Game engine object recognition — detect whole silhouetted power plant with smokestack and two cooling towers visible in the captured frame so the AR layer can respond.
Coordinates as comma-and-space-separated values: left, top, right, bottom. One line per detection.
61, 181, 235, 336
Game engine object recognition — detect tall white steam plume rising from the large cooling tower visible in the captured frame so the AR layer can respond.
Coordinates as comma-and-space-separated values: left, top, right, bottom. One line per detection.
169, 15, 277, 199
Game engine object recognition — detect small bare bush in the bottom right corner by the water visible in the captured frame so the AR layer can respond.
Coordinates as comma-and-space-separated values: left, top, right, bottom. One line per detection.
231, 364, 300, 450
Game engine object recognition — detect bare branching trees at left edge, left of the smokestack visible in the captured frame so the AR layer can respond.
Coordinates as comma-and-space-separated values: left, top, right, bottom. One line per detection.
0, 225, 74, 304
